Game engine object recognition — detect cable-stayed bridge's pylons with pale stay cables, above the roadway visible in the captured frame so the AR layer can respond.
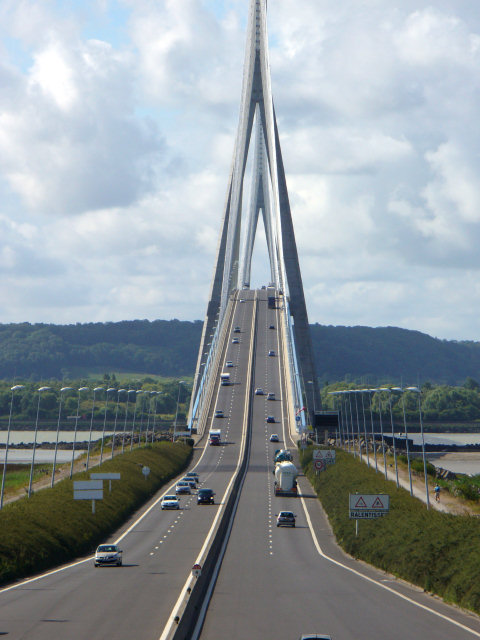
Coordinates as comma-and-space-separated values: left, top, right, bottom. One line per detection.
189, 0, 320, 440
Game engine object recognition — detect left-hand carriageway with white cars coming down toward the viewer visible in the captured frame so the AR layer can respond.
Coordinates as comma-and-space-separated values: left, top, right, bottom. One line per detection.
0, 292, 254, 640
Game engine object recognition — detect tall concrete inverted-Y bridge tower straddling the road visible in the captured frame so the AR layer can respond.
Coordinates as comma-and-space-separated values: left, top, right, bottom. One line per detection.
190, 0, 320, 430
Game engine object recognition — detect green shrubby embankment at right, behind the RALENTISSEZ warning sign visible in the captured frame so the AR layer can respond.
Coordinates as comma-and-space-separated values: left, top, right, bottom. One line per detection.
302, 448, 480, 613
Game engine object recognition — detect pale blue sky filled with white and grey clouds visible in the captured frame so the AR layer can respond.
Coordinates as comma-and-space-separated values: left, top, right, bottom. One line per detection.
0, 0, 480, 341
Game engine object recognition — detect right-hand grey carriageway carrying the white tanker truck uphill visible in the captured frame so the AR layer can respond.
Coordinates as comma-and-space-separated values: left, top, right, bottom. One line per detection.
201, 292, 480, 640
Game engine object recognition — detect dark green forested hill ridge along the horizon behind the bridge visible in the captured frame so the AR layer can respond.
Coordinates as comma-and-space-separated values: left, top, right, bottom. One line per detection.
0, 320, 480, 384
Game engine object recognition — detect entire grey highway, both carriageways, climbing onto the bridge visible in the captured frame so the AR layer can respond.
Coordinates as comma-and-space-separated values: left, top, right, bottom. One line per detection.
0, 290, 480, 640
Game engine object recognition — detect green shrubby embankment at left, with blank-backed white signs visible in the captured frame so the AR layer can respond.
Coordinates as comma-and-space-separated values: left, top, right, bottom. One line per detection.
0, 442, 192, 584
